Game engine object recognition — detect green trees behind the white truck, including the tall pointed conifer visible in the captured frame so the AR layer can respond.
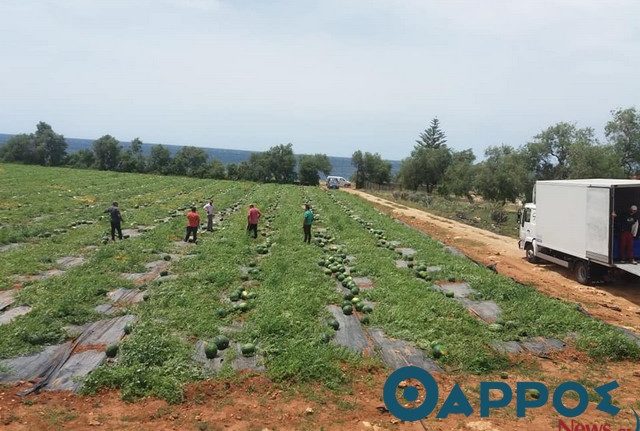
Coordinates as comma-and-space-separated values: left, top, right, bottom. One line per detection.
352, 107, 640, 203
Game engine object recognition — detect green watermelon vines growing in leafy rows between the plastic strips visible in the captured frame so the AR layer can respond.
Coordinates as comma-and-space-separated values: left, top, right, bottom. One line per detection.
0, 165, 640, 403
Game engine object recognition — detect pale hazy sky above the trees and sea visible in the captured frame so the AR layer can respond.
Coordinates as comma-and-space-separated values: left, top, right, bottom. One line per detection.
0, 0, 640, 160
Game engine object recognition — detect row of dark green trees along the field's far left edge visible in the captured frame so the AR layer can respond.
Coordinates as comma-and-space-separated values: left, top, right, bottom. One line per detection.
0, 122, 332, 185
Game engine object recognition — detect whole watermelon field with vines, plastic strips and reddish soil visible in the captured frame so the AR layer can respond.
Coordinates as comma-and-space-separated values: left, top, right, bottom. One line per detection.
0, 165, 640, 429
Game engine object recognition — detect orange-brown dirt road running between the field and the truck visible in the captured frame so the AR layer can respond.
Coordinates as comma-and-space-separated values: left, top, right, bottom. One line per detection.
343, 189, 640, 333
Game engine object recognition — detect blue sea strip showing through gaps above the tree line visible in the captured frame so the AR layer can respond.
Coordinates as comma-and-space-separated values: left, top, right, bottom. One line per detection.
0, 133, 400, 178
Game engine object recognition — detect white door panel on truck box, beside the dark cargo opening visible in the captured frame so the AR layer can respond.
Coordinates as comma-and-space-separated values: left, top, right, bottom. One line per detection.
585, 187, 611, 264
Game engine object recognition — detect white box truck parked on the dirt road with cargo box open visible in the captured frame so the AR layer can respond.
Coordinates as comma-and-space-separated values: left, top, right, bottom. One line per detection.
518, 179, 640, 284
